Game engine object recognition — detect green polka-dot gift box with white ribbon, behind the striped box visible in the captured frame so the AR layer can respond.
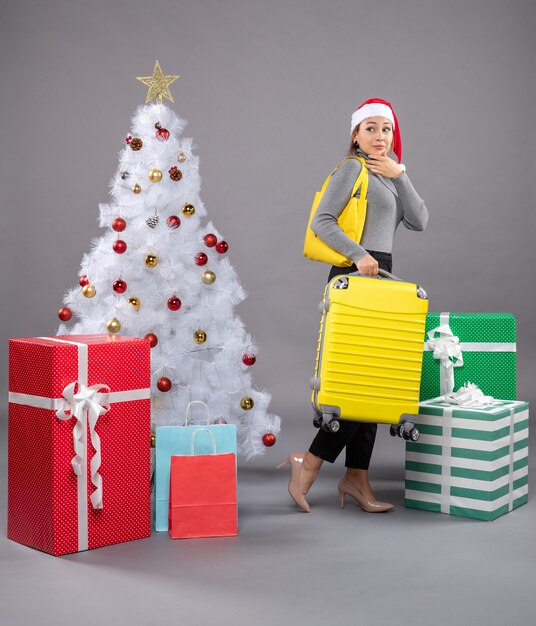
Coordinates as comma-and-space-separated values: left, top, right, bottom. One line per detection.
420, 313, 516, 401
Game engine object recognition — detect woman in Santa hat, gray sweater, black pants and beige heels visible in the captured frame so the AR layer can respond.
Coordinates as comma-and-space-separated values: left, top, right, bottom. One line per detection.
278, 98, 428, 513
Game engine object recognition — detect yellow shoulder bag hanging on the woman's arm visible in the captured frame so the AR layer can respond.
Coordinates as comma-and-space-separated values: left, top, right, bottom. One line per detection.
303, 157, 368, 267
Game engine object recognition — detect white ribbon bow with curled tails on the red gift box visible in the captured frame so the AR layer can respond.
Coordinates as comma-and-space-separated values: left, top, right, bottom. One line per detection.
56, 381, 110, 509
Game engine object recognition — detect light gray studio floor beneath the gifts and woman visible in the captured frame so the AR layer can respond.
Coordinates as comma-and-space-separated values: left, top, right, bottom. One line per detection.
0, 410, 536, 626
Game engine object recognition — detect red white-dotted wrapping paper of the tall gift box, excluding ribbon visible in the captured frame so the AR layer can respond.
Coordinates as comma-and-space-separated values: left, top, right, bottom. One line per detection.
8, 335, 150, 555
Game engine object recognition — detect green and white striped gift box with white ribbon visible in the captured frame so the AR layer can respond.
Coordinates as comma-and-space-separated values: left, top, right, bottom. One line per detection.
405, 398, 529, 521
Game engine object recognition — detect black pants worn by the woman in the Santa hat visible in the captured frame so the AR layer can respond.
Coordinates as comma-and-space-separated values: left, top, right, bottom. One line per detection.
309, 250, 393, 470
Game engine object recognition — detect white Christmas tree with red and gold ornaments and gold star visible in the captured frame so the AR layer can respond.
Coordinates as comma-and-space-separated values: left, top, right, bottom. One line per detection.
57, 61, 280, 458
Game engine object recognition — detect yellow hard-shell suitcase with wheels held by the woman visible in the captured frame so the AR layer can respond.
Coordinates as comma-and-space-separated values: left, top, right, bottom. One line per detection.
311, 270, 428, 441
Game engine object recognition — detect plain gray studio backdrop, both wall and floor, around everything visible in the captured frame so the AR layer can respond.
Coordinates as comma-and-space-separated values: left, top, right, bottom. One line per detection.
0, 0, 536, 625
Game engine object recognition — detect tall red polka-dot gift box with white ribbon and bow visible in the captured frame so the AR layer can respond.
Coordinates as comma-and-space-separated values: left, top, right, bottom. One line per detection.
7, 335, 151, 556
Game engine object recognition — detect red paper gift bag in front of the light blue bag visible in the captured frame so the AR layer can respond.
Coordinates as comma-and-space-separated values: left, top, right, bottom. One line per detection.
169, 428, 238, 539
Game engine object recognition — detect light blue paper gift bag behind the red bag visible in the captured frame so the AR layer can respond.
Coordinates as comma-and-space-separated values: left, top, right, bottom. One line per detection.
154, 400, 236, 531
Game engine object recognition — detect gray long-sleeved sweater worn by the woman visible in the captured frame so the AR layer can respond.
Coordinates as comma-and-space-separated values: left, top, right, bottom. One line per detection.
311, 154, 428, 263
